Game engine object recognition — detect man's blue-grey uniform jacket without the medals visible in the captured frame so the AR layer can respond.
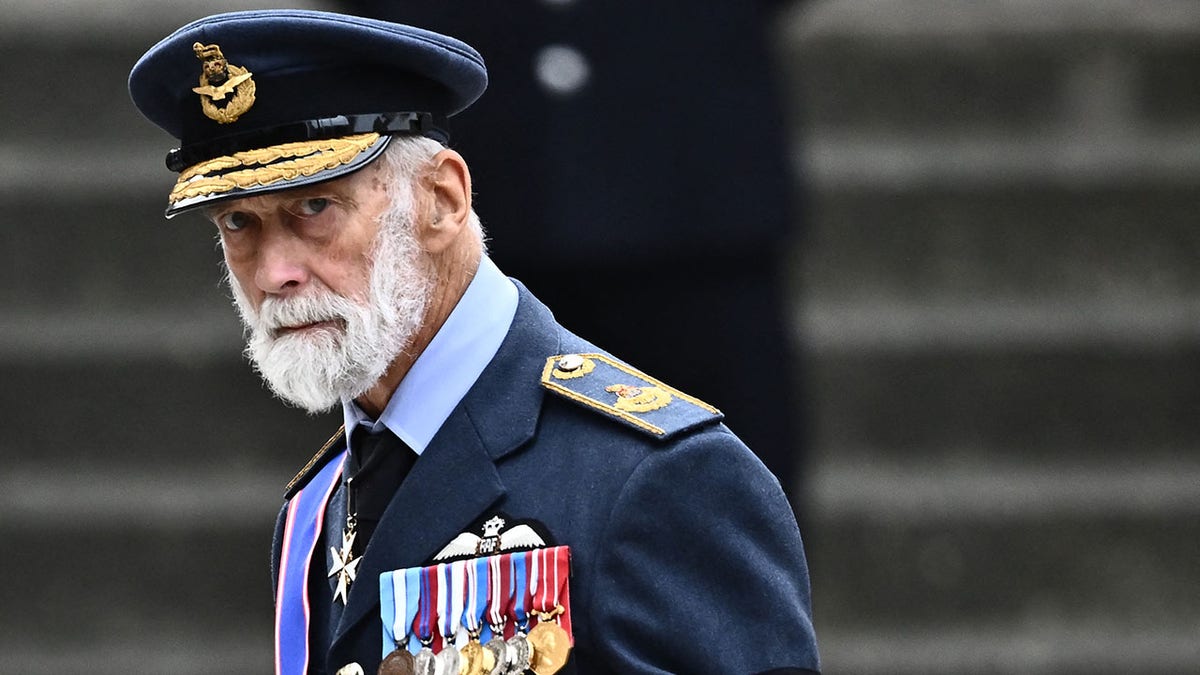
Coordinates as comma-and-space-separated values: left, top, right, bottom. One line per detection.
271, 285, 820, 675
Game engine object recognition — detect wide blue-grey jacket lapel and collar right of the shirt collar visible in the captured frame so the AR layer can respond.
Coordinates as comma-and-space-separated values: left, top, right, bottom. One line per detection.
331, 283, 558, 650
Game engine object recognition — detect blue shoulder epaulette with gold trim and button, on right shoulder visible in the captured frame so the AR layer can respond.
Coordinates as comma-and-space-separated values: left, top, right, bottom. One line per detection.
541, 354, 724, 438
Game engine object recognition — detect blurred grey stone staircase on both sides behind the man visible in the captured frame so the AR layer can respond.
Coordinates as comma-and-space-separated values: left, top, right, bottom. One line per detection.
0, 0, 1200, 675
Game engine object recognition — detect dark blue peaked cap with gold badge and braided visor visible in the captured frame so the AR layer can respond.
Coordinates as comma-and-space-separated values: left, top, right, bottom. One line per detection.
130, 10, 487, 217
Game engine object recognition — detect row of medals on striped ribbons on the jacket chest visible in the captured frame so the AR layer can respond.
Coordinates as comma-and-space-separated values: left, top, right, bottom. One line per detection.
378, 546, 574, 675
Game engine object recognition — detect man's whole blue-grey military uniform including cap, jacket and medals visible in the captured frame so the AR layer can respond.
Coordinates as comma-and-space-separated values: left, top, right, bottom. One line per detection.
130, 11, 818, 675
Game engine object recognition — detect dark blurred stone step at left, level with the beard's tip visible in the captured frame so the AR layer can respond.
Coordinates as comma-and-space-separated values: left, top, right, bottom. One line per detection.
0, 353, 341, 468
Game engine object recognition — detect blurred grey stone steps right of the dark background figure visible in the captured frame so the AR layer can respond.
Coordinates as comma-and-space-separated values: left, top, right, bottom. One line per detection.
780, 0, 1200, 674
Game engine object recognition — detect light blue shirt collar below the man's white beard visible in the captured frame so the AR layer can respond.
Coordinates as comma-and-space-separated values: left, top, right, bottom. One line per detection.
342, 256, 517, 454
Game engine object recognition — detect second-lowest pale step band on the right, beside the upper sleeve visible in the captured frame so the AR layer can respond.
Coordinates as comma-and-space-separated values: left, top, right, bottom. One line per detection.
805, 450, 1200, 523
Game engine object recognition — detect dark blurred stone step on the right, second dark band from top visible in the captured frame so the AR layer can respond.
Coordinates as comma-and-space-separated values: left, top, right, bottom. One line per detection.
798, 182, 1200, 304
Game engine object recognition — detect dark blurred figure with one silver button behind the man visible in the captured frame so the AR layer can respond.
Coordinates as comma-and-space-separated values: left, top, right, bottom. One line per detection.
333, 0, 805, 504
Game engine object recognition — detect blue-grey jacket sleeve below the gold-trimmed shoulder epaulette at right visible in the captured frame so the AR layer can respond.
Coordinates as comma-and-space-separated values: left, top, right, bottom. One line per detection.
590, 426, 820, 674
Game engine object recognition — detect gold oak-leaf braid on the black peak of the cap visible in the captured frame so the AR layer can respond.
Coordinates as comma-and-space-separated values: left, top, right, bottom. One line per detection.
168, 133, 379, 204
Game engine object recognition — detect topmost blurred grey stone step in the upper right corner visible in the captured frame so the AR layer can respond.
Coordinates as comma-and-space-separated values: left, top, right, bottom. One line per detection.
778, 0, 1200, 135
